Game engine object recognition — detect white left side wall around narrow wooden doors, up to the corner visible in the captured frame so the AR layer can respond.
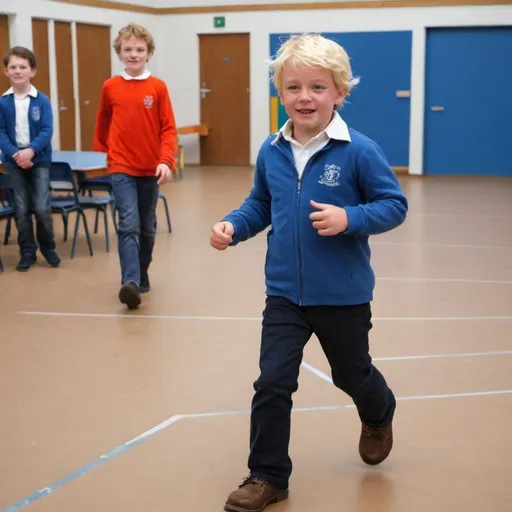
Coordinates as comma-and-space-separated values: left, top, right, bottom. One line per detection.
0, 0, 159, 149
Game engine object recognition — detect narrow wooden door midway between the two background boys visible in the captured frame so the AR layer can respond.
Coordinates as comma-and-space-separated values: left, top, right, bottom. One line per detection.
55, 21, 76, 151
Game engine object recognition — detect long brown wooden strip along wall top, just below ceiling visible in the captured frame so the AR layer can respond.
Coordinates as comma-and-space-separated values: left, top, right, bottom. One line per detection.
50, 0, 512, 15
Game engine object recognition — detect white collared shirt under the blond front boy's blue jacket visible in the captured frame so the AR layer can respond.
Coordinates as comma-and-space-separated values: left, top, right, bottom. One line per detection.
272, 112, 351, 178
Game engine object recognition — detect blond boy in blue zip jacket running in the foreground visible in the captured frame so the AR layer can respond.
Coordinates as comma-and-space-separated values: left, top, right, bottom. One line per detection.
210, 34, 407, 512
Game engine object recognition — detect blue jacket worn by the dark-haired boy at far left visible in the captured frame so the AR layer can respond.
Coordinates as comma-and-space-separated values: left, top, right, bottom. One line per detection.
0, 91, 53, 164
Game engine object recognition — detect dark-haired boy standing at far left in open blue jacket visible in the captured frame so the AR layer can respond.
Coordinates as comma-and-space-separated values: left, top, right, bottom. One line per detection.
0, 46, 60, 272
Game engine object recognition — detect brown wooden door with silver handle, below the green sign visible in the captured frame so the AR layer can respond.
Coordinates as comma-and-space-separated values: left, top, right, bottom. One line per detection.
199, 34, 250, 165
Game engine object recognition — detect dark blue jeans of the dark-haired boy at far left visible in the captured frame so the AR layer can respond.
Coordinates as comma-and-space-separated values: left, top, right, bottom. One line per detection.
6, 162, 55, 256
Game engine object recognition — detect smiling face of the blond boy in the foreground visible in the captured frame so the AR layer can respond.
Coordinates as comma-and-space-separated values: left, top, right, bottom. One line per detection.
279, 60, 344, 144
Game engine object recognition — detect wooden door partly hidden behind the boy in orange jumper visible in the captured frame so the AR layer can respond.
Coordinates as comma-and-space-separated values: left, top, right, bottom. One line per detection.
76, 23, 111, 151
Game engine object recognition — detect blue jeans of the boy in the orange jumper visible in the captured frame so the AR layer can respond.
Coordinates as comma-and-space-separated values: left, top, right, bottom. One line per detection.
111, 172, 159, 285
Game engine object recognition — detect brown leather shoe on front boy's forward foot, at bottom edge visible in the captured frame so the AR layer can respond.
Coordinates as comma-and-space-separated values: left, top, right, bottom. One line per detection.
224, 478, 288, 512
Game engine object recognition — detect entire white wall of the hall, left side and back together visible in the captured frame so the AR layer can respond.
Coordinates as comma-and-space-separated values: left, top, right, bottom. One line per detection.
0, 0, 512, 174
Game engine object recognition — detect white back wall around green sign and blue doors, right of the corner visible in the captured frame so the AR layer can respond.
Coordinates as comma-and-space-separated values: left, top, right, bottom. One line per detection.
155, 2, 512, 174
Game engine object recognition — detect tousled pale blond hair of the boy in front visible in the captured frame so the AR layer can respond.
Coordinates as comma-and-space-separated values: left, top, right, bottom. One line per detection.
269, 34, 359, 102
